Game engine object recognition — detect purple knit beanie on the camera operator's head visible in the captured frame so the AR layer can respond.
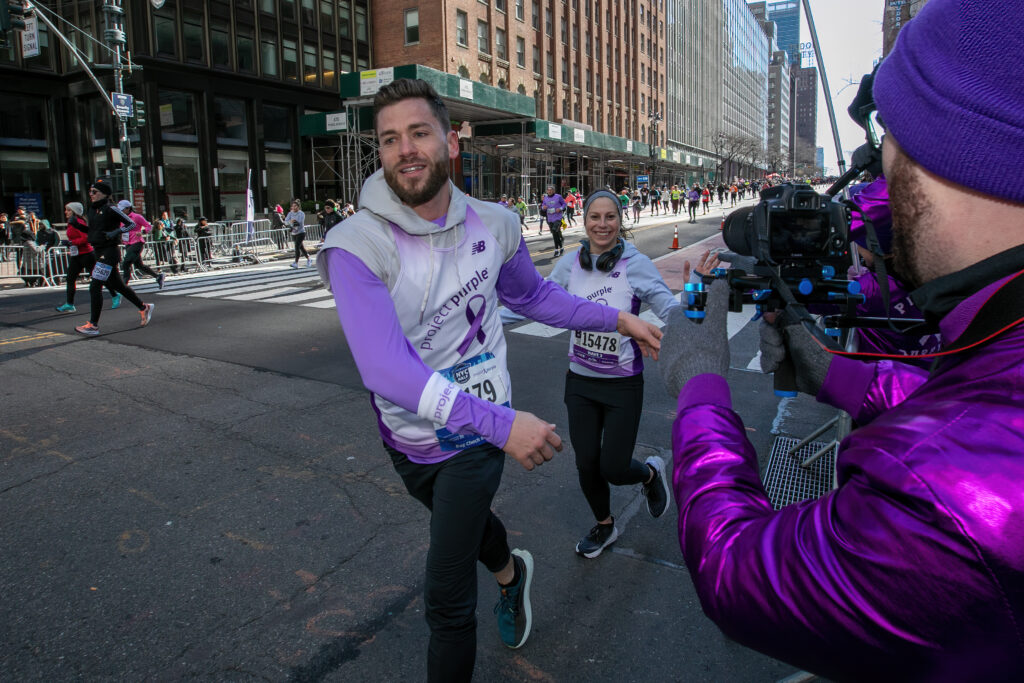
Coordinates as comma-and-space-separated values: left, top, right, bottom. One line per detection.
873, 0, 1024, 203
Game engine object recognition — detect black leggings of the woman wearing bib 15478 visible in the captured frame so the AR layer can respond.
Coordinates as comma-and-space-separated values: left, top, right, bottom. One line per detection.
565, 371, 650, 521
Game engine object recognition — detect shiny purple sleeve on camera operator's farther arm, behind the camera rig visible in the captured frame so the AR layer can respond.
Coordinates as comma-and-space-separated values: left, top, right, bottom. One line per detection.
817, 356, 928, 425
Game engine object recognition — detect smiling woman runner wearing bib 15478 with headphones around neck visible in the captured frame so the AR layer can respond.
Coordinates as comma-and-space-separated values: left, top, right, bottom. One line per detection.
551, 189, 679, 558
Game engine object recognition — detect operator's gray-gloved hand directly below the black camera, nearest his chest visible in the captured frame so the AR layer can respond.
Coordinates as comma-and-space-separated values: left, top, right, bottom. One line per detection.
758, 313, 833, 396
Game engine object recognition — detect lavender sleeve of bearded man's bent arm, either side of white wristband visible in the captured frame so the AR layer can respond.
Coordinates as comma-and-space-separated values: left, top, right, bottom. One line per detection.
326, 249, 515, 447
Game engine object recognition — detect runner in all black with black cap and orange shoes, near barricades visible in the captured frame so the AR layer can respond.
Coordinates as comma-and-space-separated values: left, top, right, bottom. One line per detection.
75, 180, 156, 337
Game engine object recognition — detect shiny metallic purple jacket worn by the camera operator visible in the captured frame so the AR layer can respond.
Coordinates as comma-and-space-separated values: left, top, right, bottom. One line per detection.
672, 270, 1024, 681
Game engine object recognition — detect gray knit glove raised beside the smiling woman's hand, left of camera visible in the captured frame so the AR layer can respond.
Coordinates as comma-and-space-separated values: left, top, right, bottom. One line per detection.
657, 280, 729, 398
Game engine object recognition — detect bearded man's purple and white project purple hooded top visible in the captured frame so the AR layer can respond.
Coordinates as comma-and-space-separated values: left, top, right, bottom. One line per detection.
316, 170, 617, 463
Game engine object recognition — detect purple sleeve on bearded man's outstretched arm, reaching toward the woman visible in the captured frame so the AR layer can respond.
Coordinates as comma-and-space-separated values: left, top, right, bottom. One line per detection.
498, 239, 618, 332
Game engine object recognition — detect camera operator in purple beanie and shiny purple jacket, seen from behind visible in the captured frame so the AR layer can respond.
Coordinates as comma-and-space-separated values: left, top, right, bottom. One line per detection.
660, 0, 1024, 681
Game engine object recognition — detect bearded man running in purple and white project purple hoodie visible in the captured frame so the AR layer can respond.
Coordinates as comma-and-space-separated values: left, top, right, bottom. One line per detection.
316, 79, 660, 683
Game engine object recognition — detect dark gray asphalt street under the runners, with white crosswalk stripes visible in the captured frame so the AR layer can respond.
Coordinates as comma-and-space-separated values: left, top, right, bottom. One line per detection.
0, 194, 826, 682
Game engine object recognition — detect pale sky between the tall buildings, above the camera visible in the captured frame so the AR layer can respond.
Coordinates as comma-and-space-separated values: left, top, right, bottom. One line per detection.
800, 0, 884, 173
